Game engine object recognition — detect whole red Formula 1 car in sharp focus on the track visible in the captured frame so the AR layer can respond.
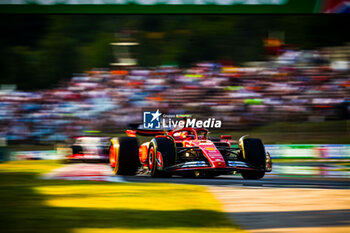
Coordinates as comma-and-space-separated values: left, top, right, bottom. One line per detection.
109, 128, 272, 179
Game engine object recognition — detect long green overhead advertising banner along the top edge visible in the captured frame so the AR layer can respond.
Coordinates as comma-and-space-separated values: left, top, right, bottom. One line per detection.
0, 0, 324, 14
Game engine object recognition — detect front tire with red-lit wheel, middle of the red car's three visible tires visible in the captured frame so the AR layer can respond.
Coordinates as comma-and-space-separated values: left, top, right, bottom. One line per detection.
148, 137, 176, 177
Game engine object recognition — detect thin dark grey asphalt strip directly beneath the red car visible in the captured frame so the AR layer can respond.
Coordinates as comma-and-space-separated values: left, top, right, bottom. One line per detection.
123, 175, 350, 189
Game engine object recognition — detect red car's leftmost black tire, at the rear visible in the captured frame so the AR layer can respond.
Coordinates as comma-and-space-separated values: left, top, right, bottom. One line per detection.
113, 137, 140, 176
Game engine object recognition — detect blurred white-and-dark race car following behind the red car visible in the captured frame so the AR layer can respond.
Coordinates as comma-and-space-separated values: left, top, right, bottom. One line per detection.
64, 136, 111, 163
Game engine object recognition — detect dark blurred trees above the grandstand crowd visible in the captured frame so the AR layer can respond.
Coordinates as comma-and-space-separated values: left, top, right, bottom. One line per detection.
0, 15, 350, 89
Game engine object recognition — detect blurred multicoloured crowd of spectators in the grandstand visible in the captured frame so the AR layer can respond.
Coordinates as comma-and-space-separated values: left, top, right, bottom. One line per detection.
0, 51, 350, 143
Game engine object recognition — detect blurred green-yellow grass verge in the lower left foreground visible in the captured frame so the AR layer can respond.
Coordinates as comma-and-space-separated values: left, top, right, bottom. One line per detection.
0, 161, 243, 233
